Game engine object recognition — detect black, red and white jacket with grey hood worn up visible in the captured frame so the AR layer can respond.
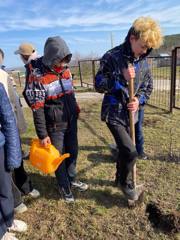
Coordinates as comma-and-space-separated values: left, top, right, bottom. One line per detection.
24, 37, 77, 139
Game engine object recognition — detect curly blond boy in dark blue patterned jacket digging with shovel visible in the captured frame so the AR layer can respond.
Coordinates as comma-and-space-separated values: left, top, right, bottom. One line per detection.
95, 17, 163, 200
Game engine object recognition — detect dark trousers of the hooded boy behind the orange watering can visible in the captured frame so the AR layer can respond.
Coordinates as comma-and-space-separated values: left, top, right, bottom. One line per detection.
48, 118, 78, 188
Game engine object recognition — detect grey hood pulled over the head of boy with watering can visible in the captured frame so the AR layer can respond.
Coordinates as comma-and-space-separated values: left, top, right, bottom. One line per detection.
42, 36, 72, 67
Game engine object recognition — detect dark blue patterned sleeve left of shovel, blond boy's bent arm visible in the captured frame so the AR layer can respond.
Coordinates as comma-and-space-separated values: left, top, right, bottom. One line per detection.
95, 53, 126, 94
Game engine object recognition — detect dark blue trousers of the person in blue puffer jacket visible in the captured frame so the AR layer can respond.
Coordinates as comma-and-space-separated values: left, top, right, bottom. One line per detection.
0, 147, 14, 239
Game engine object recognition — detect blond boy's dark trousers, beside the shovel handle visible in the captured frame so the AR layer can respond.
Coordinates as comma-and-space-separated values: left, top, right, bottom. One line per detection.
107, 123, 137, 186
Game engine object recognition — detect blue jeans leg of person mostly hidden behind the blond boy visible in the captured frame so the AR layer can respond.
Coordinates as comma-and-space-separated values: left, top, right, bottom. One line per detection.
135, 108, 144, 155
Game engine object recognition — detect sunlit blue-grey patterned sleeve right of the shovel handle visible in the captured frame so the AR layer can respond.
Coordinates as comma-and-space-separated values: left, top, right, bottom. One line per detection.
135, 63, 153, 105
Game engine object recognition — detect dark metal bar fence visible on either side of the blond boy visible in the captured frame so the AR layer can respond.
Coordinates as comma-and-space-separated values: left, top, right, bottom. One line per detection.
78, 47, 180, 112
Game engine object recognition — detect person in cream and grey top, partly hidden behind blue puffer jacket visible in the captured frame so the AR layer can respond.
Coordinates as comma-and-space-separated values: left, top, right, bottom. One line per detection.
0, 49, 40, 213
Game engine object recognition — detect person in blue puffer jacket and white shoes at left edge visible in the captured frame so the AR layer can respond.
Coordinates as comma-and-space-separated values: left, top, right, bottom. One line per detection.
0, 83, 27, 240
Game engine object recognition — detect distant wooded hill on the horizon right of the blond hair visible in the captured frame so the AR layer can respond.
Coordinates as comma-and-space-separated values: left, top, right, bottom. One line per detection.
153, 34, 180, 55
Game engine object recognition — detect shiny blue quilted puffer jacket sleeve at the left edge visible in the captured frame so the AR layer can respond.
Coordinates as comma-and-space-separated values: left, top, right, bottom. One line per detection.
0, 84, 22, 170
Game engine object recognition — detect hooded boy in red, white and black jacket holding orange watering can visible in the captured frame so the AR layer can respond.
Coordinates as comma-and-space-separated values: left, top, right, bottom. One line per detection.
24, 36, 88, 202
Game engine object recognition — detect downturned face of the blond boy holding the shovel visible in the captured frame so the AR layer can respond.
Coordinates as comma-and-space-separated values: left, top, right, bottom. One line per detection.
130, 35, 148, 58
